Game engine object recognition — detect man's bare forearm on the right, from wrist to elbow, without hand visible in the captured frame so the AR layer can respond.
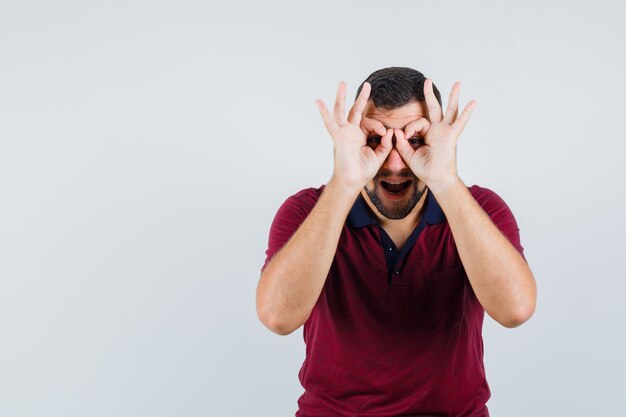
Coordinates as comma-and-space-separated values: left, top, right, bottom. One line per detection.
431, 179, 537, 327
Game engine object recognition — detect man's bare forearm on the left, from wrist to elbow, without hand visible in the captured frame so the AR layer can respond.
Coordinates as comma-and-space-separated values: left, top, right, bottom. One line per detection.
256, 181, 359, 334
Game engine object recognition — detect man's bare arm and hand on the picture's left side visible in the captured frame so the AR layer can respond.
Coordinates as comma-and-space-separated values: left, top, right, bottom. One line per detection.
256, 83, 393, 335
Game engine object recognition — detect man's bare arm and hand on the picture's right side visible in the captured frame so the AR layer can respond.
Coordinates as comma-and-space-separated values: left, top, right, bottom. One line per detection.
396, 79, 537, 327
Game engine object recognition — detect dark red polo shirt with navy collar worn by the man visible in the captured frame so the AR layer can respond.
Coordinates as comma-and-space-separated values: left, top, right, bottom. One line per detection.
262, 185, 523, 417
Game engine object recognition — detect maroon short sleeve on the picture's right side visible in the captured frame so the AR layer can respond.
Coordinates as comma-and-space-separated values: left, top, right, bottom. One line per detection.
470, 185, 528, 262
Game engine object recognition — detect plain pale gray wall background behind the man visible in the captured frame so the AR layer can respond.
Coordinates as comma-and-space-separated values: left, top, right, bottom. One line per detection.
0, 0, 626, 417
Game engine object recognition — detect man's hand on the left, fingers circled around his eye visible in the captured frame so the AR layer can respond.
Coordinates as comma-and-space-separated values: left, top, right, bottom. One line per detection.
315, 81, 394, 190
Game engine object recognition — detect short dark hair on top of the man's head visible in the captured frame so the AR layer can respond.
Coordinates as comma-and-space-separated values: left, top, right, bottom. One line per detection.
355, 67, 442, 110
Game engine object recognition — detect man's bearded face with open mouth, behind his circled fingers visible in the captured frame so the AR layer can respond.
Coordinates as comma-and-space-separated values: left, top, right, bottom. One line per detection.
362, 100, 428, 219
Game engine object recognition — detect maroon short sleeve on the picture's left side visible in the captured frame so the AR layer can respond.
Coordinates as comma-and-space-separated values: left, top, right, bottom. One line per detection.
261, 186, 323, 272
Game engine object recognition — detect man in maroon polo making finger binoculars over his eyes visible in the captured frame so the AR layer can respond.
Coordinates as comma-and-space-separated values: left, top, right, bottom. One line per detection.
257, 68, 536, 417
